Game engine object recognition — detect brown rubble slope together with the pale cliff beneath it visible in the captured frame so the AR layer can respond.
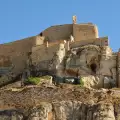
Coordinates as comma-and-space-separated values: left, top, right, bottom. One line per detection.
0, 84, 120, 120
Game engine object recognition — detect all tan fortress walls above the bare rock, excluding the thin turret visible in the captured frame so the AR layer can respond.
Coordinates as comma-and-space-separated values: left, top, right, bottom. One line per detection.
0, 23, 112, 78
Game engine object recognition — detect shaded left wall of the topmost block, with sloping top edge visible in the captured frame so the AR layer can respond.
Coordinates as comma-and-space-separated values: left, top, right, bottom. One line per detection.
43, 24, 73, 41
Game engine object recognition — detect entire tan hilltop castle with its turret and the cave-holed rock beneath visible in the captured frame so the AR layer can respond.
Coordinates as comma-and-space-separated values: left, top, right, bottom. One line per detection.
0, 16, 120, 88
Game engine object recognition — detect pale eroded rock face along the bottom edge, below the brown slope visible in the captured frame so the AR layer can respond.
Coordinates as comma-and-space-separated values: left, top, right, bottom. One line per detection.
0, 101, 119, 120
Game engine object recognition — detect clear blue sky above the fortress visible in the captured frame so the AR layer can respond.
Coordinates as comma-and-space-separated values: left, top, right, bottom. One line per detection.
0, 0, 120, 51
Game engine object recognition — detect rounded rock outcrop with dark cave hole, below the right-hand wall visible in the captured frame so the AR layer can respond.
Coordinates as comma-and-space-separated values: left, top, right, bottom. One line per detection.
62, 45, 116, 88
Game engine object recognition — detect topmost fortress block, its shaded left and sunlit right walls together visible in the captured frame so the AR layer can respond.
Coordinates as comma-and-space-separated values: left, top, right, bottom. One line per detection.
42, 23, 99, 41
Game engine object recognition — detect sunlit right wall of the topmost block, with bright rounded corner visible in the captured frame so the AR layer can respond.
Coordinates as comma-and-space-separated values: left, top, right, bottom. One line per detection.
73, 24, 98, 41
